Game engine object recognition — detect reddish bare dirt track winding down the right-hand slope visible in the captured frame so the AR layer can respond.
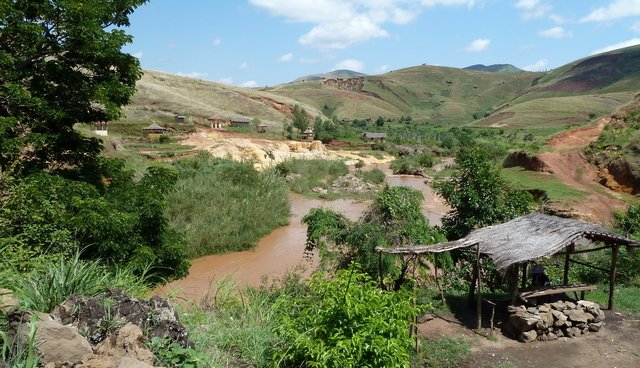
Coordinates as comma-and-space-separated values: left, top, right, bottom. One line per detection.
537, 117, 625, 224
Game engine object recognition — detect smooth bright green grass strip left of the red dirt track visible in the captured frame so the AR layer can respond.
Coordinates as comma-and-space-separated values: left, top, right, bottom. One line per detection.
502, 167, 587, 201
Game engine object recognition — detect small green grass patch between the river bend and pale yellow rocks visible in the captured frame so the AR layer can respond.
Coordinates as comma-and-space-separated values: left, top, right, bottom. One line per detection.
276, 159, 349, 194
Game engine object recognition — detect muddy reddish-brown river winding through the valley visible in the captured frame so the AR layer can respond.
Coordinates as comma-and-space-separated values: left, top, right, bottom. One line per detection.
158, 167, 447, 299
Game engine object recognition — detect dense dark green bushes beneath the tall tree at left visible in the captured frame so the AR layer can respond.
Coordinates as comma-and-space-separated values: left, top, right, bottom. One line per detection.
0, 159, 189, 281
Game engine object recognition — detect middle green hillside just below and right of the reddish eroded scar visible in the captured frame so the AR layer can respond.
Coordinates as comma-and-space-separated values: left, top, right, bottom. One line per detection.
271, 66, 541, 123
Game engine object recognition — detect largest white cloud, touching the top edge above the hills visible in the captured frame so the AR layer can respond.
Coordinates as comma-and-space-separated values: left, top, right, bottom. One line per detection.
249, 0, 480, 51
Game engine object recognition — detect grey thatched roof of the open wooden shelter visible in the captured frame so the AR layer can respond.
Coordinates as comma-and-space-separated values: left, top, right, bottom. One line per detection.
377, 213, 640, 272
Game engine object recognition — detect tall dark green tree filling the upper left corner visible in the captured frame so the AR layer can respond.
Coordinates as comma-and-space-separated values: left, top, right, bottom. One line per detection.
0, 0, 146, 175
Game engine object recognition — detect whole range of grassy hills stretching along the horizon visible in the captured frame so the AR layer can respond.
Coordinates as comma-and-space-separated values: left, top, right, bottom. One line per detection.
117, 46, 640, 129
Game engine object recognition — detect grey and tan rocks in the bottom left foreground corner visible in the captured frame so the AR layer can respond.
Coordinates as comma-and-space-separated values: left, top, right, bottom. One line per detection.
8, 290, 189, 368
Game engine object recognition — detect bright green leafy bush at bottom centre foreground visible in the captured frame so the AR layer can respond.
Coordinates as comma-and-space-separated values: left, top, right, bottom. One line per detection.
273, 265, 418, 368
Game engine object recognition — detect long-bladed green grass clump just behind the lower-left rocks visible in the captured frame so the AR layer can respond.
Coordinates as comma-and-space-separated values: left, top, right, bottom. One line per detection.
0, 253, 149, 312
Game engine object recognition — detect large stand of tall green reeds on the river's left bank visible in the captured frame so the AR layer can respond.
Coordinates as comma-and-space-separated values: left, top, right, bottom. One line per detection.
167, 153, 290, 257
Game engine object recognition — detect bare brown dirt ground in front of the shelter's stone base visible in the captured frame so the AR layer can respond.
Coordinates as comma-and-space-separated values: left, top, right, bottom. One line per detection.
419, 311, 640, 368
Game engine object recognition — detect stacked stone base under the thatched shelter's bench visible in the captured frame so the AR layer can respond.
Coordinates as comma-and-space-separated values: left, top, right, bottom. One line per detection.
503, 300, 604, 342
